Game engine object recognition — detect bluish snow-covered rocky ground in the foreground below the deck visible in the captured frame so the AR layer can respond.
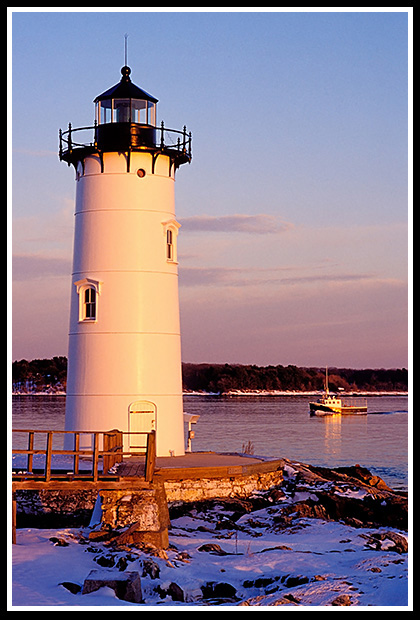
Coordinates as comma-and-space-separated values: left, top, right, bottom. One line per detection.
10, 504, 409, 611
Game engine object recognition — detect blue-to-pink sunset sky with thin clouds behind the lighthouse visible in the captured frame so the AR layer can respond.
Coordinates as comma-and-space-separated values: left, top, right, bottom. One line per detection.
9, 7, 412, 368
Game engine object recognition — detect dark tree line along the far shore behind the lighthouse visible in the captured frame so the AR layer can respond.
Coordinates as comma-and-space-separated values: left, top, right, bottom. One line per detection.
12, 356, 408, 393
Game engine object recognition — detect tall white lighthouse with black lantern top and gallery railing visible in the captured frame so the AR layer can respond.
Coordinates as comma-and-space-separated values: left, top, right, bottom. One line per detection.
59, 66, 191, 456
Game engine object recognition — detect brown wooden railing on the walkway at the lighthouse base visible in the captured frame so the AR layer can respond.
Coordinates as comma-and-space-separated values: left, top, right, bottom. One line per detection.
12, 429, 156, 482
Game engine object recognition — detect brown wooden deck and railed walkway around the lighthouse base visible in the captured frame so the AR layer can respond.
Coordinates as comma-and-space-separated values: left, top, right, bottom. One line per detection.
12, 429, 284, 542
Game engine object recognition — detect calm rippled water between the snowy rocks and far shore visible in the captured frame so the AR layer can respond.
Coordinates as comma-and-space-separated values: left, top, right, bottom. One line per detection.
12, 395, 408, 490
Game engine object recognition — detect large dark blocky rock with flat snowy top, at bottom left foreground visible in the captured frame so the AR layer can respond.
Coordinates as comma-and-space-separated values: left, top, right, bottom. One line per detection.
82, 569, 142, 603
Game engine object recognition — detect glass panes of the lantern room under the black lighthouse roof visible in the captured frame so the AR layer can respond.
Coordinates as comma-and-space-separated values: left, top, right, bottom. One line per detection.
96, 99, 156, 127
